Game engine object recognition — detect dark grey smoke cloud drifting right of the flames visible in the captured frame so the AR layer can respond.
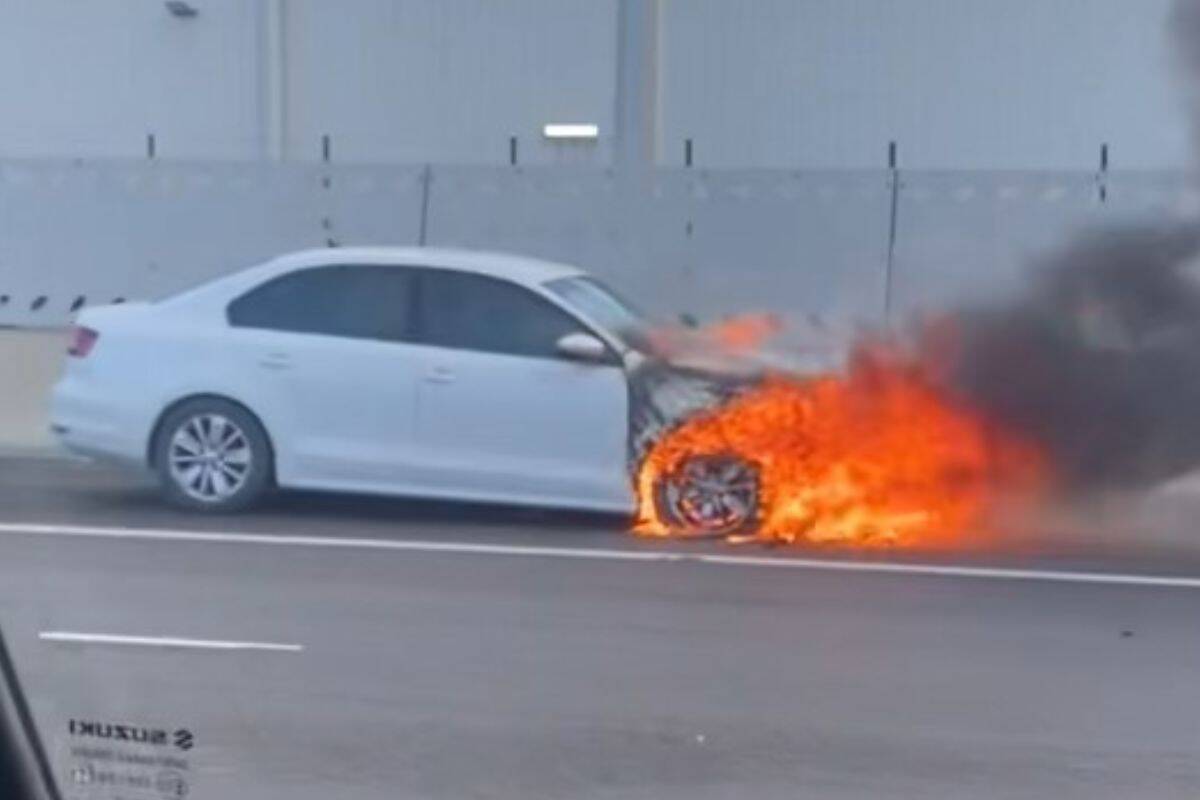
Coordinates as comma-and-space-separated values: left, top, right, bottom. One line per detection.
926, 224, 1200, 492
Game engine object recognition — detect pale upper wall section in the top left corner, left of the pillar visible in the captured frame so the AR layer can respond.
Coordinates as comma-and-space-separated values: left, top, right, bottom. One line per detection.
0, 0, 262, 158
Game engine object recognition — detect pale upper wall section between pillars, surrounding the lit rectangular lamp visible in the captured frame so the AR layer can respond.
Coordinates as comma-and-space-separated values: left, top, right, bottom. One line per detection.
286, 0, 617, 164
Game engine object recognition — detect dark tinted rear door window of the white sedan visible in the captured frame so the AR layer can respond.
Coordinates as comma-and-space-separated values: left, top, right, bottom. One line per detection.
229, 266, 414, 341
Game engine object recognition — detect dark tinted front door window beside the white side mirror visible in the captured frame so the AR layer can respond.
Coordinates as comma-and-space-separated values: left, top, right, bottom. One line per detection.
420, 270, 583, 357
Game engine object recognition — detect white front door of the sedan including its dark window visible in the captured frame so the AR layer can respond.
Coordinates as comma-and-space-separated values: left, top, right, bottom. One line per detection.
415, 269, 631, 510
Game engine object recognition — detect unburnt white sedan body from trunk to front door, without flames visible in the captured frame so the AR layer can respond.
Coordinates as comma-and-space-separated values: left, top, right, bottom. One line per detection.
52, 248, 748, 520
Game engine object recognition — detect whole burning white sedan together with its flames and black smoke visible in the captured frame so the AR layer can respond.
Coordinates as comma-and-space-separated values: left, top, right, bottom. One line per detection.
72, 242, 1180, 545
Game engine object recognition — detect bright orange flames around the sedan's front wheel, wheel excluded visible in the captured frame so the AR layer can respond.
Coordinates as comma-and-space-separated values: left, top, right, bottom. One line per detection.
635, 348, 1046, 546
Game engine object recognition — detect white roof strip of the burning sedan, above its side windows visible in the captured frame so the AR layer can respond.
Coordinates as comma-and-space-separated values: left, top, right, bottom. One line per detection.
263, 247, 584, 285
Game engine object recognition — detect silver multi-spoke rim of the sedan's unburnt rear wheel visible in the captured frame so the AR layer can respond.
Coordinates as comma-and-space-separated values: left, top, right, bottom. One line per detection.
167, 414, 254, 503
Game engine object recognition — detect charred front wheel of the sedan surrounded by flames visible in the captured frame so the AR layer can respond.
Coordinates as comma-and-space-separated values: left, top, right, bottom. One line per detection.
654, 456, 758, 537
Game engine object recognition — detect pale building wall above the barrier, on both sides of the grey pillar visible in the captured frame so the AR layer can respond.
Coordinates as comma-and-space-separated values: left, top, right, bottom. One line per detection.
0, 0, 1189, 169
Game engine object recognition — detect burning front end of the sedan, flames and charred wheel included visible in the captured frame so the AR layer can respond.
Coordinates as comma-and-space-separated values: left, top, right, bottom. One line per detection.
636, 333, 1044, 546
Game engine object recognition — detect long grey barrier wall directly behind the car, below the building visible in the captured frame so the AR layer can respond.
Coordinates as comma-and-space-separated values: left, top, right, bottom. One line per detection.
0, 161, 1200, 327
